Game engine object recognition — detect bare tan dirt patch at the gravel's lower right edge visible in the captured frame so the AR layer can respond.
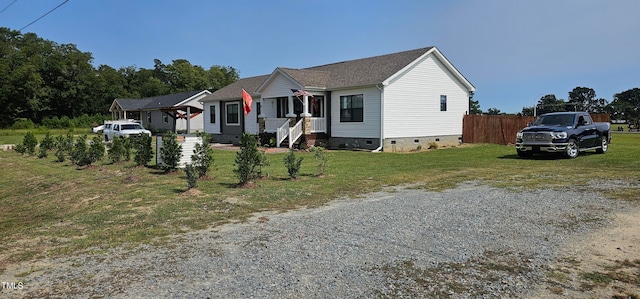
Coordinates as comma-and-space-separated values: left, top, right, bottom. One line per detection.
536, 207, 640, 298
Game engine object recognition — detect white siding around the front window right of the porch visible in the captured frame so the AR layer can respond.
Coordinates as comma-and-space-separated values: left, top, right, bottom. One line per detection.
331, 87, 380, 138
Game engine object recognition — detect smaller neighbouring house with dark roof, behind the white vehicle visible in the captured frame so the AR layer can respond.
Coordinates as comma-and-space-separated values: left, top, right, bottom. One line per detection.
109, 90, 211, 133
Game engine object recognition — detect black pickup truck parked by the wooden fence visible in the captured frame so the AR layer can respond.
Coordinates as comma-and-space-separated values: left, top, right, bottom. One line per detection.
516, 112, 611, 158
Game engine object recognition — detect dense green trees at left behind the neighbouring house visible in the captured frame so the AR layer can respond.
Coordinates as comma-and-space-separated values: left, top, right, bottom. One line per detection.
0, 27, 239, 128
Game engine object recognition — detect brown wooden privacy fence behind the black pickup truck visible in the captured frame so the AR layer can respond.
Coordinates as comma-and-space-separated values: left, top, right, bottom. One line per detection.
462, 114, 611, 145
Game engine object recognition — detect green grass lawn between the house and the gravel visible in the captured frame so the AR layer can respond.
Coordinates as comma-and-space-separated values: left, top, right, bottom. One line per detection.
0, 132, 640, 272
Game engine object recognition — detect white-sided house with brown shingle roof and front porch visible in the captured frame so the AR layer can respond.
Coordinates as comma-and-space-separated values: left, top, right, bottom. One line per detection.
202, 47, 475, 151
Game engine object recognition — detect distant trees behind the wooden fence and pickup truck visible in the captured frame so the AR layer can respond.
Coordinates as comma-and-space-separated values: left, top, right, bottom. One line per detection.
471, 87, 640, 124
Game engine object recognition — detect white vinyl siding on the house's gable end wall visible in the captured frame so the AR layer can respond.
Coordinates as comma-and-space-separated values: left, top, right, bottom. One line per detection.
384, 54, 469, 139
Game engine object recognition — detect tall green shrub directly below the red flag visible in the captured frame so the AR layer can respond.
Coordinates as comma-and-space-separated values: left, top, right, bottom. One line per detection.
233, 133, 261, 185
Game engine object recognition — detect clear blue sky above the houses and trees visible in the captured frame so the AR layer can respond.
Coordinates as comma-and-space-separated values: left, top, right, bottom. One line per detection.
0, 0, 640, 113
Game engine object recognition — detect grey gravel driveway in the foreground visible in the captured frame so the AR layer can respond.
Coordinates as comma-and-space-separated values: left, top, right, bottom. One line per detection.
13, 183, 626, 298
